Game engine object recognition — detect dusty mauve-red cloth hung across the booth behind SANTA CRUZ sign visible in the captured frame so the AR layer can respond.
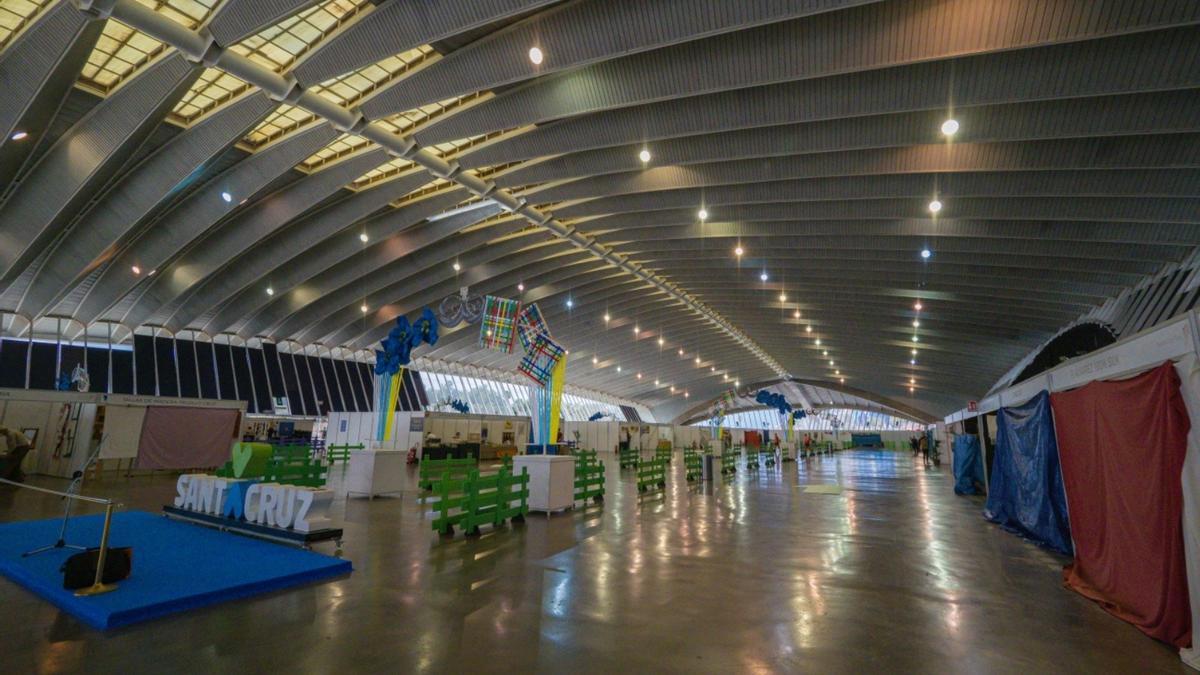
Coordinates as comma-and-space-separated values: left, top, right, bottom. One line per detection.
137, 406, 238, 468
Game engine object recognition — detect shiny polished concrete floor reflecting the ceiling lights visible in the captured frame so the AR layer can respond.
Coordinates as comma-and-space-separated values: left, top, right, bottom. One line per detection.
0, 450, 1188, 675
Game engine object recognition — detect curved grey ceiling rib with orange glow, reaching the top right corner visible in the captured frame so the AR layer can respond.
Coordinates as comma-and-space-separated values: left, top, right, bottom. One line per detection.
405, 0, 1200, 144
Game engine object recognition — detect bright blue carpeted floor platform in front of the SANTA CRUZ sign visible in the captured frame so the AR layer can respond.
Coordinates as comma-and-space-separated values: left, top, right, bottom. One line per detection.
0, 510, 352, 631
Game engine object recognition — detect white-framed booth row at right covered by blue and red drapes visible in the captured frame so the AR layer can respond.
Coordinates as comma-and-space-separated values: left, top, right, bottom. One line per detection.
946, 311, 1200, 668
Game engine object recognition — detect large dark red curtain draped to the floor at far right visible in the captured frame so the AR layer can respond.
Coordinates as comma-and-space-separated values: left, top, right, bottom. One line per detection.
1050, 363, 1192, 647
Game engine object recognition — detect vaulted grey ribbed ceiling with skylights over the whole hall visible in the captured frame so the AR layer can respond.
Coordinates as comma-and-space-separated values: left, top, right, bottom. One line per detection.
0, 0, 1200, 417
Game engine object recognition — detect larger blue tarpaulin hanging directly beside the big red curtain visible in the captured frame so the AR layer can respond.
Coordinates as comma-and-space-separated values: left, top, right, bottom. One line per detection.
984, 392, 1072, 555
